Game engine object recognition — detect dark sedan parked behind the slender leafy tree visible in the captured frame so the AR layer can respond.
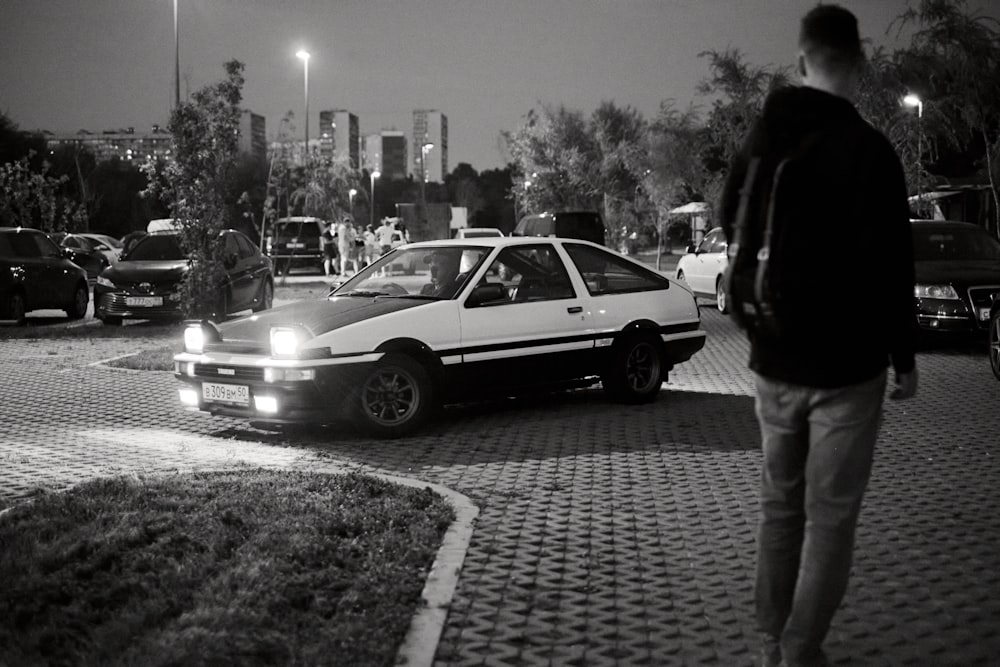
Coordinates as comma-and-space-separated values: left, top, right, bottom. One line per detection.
94, 229, 274, 325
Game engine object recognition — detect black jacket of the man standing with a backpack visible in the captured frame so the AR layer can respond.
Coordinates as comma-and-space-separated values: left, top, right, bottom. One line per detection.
720, 87, 917, 387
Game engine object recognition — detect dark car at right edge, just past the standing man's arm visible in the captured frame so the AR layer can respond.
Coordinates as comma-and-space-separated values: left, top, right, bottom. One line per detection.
911, 220, 1000, 332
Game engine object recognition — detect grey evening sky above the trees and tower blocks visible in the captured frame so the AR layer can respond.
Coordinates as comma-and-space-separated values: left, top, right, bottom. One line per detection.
0, 0, 1000, 170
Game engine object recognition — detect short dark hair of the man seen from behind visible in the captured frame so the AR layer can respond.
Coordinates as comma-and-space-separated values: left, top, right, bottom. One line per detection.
799, 5, 865, 70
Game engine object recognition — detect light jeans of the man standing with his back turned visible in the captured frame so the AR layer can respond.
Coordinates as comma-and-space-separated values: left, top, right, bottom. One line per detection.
755, 372, 886, 665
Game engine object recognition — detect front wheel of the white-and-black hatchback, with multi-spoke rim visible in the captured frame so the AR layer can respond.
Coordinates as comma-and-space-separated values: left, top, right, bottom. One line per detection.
351, 354, 435, 438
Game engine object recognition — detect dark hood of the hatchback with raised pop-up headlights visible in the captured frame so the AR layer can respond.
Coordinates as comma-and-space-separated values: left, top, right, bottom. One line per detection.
219, 296, 435, 345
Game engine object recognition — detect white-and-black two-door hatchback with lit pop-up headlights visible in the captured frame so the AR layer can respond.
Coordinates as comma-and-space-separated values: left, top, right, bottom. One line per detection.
174, 237, 705, 437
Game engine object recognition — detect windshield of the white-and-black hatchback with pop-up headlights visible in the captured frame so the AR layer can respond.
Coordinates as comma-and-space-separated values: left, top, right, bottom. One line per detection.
332, 246, 491, 299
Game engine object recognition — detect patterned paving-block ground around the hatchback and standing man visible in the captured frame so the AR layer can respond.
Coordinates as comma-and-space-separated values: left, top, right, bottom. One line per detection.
0, 307, 1000, 666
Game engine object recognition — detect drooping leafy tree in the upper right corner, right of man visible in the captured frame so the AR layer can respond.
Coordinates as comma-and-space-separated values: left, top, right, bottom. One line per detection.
898, 0, 1000, 235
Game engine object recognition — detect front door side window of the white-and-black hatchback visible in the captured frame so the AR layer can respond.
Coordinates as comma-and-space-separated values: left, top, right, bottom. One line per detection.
480, 244, 576, 305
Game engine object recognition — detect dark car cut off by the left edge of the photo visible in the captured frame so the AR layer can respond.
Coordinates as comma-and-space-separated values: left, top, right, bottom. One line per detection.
0, 227, 90, 325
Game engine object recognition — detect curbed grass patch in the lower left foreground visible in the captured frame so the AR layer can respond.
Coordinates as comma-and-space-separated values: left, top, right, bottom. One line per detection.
0, 470, 454, 665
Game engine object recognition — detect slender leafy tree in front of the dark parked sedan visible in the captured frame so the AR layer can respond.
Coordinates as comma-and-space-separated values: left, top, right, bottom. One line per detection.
142, 60, 243, 318
